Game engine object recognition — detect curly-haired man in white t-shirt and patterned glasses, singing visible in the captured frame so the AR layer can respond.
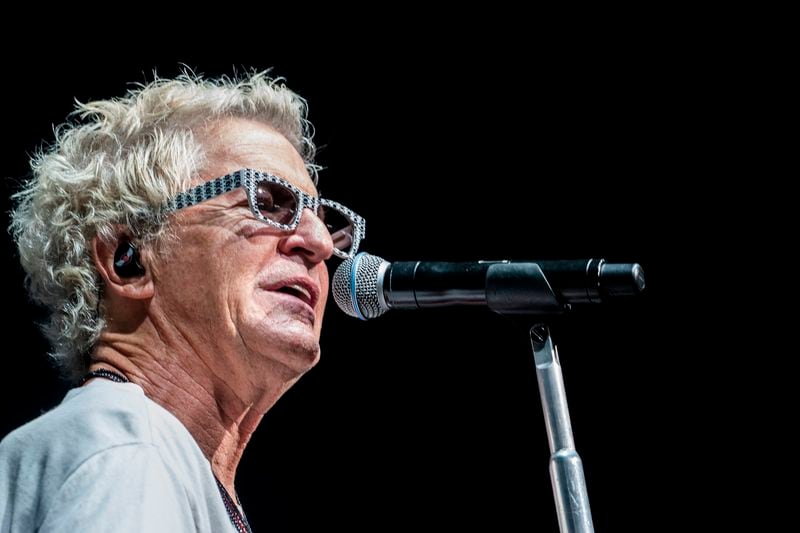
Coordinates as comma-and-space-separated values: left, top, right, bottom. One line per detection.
0, 73, 364, 532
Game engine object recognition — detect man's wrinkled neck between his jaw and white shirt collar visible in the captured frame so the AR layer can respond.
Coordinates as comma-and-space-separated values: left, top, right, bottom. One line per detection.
90, 326, 300, 495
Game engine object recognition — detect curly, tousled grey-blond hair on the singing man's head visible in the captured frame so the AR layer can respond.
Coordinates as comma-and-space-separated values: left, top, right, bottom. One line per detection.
10, 72, 319, 380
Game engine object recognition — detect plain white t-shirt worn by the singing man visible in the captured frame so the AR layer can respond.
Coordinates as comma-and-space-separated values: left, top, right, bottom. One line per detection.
0, 379, 236, 533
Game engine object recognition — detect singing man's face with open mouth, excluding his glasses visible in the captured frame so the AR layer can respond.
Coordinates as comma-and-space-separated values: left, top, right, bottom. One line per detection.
153, 118, 333, 381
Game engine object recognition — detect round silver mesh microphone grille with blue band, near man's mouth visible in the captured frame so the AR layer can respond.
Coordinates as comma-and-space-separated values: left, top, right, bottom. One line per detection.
333, 252, 389, 320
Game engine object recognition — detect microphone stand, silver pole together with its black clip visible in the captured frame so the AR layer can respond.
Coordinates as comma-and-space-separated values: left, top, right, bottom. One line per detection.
486, 263, 594, 533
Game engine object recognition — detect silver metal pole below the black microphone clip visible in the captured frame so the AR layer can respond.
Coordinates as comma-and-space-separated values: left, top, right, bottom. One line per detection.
530, 325, 594, 533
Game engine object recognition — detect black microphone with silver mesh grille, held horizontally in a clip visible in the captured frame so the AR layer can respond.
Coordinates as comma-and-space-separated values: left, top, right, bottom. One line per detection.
333, 252, 645, 320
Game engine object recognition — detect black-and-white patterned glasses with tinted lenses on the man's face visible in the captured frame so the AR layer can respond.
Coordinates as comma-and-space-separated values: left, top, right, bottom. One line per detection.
166, 168, 366, 259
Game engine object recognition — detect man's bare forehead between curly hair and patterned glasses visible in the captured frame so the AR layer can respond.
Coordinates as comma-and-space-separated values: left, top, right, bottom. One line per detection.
198, 118, 317, 196
